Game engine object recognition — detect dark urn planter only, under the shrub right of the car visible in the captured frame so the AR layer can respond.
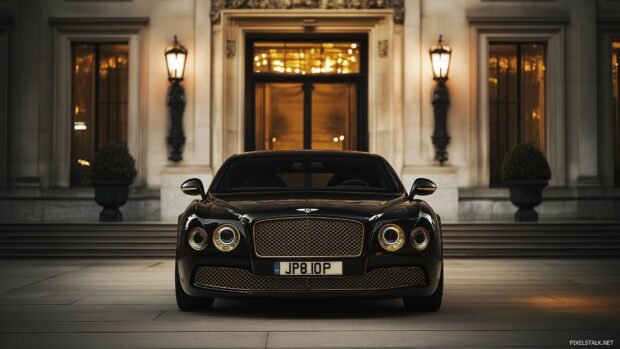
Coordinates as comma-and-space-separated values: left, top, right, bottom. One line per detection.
504, 180, 548, 222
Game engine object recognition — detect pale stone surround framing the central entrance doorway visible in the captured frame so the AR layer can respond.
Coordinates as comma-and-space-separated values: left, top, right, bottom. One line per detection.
213, 9, 404, 173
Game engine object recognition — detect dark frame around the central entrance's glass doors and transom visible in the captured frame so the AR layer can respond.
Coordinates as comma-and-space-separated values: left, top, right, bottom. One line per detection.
244, 33, 369, 151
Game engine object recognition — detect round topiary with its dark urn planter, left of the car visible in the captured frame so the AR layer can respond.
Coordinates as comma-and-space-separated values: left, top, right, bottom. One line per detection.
91, 144, 136, 222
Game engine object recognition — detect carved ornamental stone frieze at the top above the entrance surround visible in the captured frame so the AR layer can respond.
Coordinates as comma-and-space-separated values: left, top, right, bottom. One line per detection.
211, 0, 405, 24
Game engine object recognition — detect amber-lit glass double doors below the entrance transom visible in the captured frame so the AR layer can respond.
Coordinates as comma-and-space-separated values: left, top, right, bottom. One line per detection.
254, 82, 358, 150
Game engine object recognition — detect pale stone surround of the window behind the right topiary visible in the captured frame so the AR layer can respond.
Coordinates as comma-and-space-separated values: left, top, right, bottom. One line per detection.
470, 20, 566, 188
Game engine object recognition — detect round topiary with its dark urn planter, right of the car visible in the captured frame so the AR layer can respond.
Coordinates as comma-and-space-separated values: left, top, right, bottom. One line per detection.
502, 144, 551, 221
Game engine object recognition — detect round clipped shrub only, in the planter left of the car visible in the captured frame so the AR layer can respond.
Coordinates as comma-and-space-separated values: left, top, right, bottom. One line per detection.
91, 144, 137, 182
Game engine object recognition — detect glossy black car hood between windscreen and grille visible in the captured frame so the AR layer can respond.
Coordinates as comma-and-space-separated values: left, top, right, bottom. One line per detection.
213, 193, 408, 219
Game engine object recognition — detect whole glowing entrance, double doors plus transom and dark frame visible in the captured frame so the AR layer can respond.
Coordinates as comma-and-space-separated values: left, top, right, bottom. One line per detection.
245, 37, 367, 150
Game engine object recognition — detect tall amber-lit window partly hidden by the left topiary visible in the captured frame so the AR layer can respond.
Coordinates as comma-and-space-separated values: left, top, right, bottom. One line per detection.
70, 43, 128, 187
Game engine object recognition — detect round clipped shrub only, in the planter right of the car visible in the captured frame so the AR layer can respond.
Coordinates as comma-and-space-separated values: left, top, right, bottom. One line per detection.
502, 144, 551, 181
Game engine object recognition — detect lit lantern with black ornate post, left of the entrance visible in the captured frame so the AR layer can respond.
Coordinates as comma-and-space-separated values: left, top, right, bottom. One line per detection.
165, 35, 187, 162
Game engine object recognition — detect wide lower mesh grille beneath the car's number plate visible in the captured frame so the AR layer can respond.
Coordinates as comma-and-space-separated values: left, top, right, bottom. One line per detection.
194, 267, 426, 292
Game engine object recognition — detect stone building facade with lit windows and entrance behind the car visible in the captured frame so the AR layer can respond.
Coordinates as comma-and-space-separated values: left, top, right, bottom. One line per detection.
0, 0, 620, 221
